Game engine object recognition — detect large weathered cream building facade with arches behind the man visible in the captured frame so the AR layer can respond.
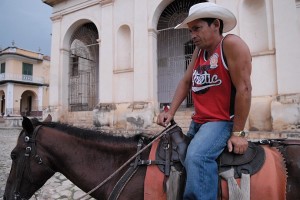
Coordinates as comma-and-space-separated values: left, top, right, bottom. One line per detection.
43, 0, 300, 136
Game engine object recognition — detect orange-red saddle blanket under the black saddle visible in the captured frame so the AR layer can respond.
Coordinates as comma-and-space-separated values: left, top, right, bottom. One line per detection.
144, 145, 287, 200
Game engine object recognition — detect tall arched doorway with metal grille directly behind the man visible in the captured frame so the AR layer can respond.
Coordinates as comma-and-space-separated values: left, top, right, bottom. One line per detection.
157, 0, 206, 107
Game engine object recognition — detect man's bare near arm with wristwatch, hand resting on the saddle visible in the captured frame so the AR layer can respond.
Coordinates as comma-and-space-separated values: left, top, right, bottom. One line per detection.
224, 35, 252, 154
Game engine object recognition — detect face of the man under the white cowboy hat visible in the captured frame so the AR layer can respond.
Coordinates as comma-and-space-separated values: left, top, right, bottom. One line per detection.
188, 19, 216, 49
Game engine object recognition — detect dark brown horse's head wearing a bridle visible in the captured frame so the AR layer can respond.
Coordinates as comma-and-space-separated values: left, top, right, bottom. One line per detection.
3, 116, 55, 200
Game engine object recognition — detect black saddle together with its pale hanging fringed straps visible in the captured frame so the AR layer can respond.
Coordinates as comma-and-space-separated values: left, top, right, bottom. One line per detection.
155, 130, 265, 200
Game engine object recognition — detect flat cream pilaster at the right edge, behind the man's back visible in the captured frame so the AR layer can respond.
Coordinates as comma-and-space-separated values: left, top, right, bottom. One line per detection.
273, 0, 300, 94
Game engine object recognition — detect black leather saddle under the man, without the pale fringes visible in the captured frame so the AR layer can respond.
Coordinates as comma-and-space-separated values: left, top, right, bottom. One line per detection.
156, 126, 265, 178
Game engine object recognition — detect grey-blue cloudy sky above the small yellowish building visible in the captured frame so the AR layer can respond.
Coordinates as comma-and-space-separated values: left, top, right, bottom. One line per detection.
0, 0, 52, 56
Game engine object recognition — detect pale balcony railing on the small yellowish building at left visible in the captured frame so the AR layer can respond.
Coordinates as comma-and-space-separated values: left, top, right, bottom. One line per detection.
0, 73, 45, 84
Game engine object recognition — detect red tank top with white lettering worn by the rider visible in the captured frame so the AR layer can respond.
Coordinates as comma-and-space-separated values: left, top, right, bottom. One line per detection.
192, 39, 235, 123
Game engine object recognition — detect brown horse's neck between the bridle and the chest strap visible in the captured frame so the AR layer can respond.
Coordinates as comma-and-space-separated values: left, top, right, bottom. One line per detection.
42, 130, 135, 191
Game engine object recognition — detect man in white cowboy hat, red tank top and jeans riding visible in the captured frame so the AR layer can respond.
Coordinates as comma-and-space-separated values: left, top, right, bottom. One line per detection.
157, 2, 251, 200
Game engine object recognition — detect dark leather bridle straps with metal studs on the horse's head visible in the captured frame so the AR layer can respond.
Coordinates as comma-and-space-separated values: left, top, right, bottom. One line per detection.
14, 125, 55, 200
